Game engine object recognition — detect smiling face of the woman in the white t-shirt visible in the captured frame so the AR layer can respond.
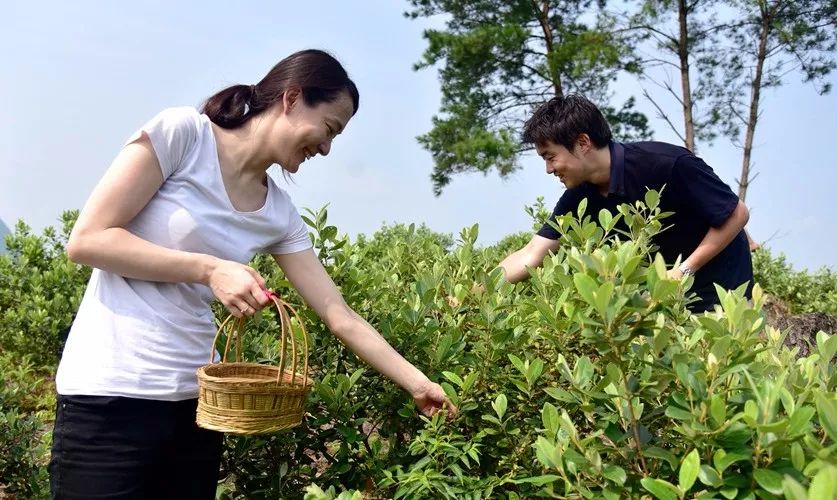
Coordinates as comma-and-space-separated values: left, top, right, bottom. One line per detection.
277, 92, 354, 173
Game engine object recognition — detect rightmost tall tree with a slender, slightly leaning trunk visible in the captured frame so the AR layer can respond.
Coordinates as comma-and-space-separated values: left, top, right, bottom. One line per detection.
718, 0, 837, 201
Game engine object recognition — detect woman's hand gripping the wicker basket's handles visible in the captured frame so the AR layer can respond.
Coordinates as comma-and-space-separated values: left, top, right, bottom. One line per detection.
208, 260, 270, 318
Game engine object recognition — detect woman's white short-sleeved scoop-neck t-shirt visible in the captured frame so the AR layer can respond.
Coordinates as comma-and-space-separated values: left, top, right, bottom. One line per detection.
56, 107, 311, 401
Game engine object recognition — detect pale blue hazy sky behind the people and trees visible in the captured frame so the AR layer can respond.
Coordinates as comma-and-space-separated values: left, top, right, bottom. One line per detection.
0, 0, 837, 269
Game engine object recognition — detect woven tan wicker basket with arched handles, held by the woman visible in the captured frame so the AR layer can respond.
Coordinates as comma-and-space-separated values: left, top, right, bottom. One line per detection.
196, 292, 313, 435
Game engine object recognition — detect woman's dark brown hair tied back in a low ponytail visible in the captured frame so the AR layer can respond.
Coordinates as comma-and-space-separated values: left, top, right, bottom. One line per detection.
201, 49, 360, 129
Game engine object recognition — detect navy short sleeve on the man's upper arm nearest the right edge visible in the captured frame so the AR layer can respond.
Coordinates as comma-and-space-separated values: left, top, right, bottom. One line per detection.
671, 155, 738, 227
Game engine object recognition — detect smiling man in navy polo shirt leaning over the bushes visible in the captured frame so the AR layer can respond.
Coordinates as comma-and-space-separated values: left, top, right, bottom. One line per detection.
500, 95, 753, 312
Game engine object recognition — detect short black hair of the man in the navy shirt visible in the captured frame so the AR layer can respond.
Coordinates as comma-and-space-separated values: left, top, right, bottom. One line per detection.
521, 94, 613, 151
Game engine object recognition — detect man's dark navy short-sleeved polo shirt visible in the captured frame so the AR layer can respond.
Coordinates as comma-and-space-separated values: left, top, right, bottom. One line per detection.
537, 142, 753, 311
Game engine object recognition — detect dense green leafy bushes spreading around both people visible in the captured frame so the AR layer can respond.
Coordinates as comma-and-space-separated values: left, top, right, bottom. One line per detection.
0, 201, 837, 500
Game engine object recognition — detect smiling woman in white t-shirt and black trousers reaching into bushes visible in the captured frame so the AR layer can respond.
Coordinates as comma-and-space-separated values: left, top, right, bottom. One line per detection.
49, 50, 456, 499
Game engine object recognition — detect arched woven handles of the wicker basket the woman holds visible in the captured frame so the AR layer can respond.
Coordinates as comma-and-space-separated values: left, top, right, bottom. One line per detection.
209, 288, 308, 387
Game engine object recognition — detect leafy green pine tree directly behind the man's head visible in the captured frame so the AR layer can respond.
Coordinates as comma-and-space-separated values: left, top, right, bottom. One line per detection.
407, 0, 649, 195
